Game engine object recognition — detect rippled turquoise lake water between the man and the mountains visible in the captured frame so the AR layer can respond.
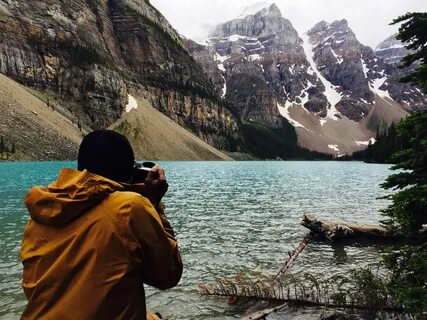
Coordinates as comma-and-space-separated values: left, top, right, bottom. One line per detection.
0, 162, 390, 319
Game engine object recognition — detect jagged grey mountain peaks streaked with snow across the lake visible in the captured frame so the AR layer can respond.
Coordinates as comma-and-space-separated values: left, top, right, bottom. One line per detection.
184, 4, 427, 155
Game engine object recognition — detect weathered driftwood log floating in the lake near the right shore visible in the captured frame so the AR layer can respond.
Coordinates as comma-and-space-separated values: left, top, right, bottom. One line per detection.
301, 214, 427, 241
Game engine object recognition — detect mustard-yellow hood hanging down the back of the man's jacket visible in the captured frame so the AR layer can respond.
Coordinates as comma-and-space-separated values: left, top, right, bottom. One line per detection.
25, 169, 123, 227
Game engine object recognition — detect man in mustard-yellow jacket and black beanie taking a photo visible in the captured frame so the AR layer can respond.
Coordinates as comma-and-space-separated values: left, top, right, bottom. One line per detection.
21, 130, 182, 320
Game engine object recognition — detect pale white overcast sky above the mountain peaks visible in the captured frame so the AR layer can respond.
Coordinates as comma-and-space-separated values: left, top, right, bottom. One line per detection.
151, 0, 427, 47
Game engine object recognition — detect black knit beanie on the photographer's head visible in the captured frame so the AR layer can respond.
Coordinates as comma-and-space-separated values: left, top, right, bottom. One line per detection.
77, 130, 135, 182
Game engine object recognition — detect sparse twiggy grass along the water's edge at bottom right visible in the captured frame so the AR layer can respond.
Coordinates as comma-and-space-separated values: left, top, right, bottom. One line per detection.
198, 269, 410, 319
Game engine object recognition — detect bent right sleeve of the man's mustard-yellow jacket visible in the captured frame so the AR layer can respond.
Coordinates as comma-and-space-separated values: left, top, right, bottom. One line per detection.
125, 196, 182, 290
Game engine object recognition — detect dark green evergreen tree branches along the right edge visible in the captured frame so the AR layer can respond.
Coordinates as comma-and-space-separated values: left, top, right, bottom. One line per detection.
383, 13, 427, 319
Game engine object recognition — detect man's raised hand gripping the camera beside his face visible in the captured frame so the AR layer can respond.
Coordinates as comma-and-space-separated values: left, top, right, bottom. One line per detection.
124, 166, 169, 208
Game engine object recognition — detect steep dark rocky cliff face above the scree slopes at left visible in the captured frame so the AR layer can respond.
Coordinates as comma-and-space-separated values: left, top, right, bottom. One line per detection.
0, 0, 238, 148
